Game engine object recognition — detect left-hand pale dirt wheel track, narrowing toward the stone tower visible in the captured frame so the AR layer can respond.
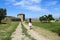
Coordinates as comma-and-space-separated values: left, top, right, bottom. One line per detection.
11, 23, 30, 40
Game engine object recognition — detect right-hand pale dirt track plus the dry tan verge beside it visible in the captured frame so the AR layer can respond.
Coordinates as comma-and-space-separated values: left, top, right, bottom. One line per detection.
23, 23, 60, 40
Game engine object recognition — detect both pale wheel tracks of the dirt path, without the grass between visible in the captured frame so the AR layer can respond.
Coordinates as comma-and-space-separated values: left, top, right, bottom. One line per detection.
11, 23, 59, 40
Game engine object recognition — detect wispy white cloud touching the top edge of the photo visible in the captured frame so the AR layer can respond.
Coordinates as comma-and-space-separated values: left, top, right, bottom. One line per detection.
14, 0, 41, 5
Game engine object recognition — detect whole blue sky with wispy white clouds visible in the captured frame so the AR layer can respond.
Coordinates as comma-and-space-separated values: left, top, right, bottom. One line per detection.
0, 0, 60, 18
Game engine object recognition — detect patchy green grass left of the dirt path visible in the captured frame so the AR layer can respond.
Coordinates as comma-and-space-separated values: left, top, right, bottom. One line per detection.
0, 22, 19, 40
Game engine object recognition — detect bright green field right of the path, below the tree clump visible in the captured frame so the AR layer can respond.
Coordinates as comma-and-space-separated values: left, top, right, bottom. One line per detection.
33, 22, 60, 35
